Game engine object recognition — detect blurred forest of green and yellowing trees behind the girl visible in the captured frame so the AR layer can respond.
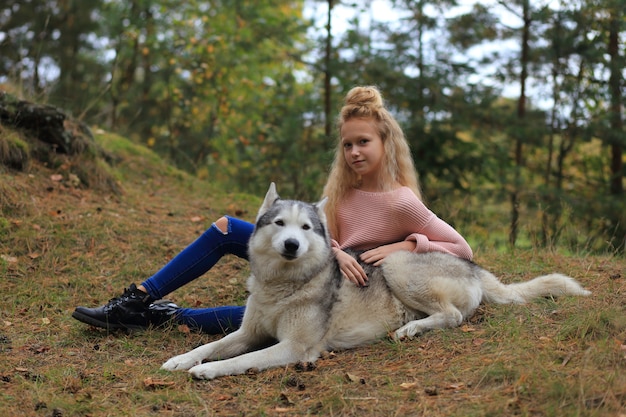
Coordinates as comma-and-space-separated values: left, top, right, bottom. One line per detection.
0, 0, 626, 253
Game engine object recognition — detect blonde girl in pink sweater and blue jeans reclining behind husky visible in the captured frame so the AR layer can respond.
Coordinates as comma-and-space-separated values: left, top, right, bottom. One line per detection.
72, 86, 472, 334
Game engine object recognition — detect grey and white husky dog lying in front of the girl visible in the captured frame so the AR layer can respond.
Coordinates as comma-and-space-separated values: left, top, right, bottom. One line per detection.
163, 183, 590, 379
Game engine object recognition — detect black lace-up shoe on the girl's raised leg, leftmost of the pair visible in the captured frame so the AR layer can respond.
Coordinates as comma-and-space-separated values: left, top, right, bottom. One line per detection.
72, 284, 154, 330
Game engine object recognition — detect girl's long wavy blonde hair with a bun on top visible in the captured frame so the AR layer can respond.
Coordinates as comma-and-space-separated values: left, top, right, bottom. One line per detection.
324, 86, 422, 236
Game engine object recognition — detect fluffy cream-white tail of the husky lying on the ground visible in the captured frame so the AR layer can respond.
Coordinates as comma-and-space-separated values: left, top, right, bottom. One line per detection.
480, 271, 591, 304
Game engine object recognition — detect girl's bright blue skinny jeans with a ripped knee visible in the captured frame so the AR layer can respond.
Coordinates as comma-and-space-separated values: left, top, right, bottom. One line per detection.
142, 216, 254, 334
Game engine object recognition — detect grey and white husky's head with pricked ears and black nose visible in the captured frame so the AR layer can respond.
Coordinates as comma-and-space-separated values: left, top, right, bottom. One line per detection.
250, 183, 330, 261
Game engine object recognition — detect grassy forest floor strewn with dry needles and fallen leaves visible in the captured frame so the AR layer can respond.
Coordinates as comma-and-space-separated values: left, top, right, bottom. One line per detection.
0, 134, 626, 417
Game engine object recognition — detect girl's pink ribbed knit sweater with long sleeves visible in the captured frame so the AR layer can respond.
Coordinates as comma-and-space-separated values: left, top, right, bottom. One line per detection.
333, 187, 472, 260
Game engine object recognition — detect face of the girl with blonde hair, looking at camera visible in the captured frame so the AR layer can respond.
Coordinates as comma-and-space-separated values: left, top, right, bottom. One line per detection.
340, 118, 385, 181
